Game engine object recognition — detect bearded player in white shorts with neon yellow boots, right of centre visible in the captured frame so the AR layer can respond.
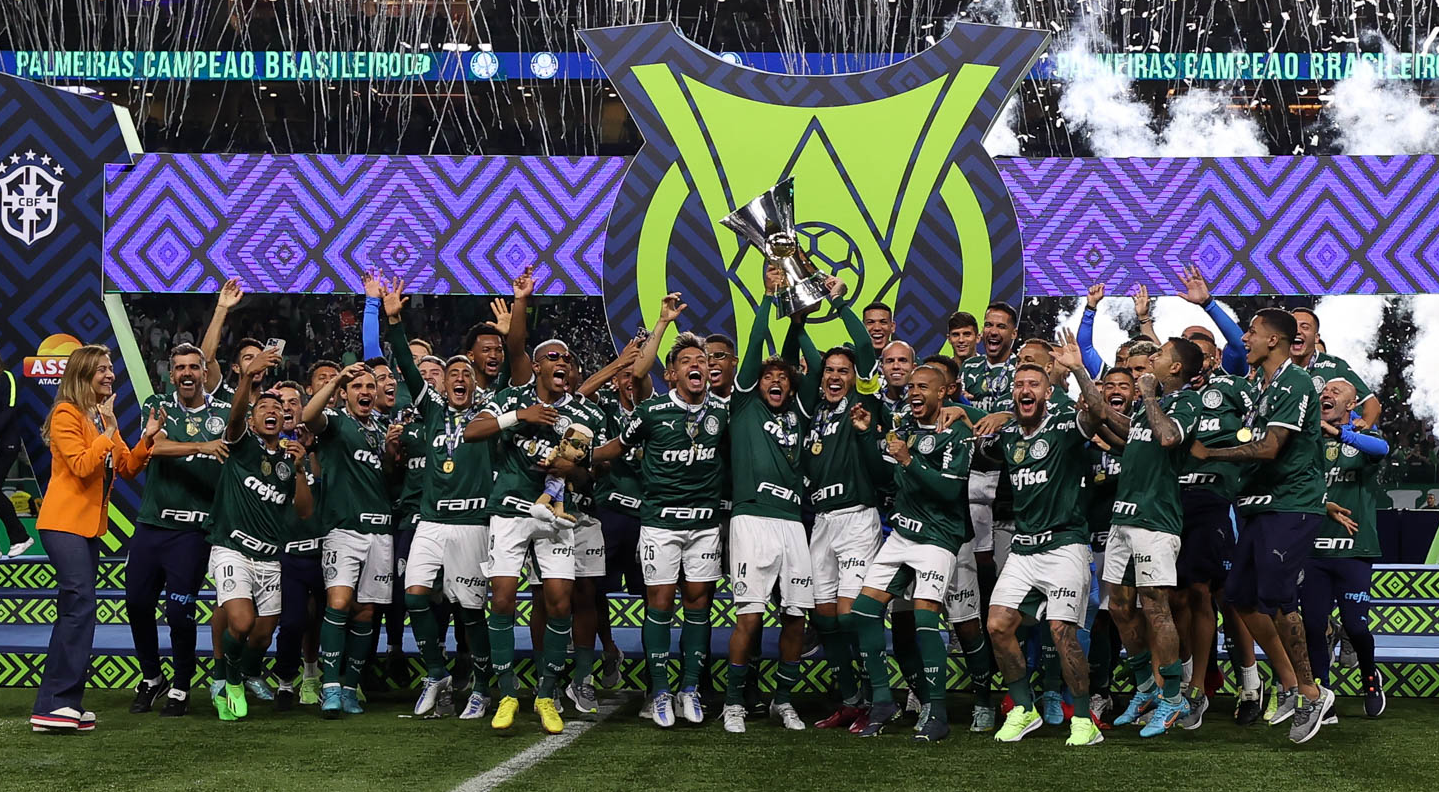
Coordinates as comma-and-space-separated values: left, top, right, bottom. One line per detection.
979, 361, 1104, 746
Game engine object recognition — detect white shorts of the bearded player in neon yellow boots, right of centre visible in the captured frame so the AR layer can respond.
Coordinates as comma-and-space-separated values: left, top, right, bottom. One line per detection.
990, 544, 1089, 625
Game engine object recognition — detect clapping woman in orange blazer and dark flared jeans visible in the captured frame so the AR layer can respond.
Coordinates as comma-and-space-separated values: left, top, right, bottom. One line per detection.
30, 344, 164, 732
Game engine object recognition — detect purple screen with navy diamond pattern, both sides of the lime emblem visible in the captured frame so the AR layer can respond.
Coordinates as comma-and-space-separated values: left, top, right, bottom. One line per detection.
105, 154, 1439, 295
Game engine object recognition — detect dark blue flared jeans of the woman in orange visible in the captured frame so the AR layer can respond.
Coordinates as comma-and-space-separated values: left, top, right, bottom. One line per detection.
35, 531, 99, 714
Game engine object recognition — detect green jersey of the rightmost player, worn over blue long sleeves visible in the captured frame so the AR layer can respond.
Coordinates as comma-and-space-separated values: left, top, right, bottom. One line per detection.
1312, 428, 1384, 559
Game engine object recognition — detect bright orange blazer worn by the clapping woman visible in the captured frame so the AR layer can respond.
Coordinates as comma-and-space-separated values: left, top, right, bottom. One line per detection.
35, 403, 153, 537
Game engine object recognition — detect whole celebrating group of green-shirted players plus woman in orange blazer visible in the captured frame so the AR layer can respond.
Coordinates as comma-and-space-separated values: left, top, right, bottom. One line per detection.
30, 257, 1389, 746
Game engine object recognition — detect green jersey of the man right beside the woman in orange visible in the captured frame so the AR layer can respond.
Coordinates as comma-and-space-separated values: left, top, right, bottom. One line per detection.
137, 393, 230, 530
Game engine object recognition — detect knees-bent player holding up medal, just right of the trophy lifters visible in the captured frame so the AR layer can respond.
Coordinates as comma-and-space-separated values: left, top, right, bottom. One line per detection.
852, 366, 973, 742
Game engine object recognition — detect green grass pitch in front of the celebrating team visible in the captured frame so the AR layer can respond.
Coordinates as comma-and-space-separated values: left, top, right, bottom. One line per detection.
0, 690, 1439, 792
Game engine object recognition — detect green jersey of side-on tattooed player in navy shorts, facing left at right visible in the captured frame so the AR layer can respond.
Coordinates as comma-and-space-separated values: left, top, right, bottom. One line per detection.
1238, 360, 1324, 517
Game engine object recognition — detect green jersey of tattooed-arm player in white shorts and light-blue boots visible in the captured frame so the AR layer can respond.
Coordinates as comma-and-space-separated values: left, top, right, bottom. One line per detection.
1111, 387, 1202, 534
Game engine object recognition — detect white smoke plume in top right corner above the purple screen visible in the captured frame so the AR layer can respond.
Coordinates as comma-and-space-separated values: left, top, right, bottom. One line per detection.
1324, 32, 1439, 156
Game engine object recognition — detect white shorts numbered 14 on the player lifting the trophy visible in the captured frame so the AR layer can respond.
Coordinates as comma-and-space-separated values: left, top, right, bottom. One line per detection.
730, 514, 814, 616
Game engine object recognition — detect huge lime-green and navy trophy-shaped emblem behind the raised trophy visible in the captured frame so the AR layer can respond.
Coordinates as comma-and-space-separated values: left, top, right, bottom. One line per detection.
580, 22, 1049, 348
